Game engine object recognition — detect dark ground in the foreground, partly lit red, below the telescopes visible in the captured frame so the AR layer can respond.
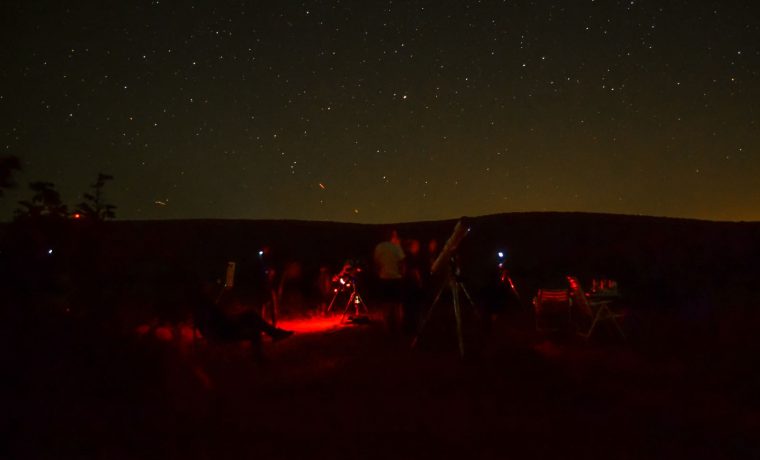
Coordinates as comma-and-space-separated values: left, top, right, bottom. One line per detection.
0, 309, 760, 459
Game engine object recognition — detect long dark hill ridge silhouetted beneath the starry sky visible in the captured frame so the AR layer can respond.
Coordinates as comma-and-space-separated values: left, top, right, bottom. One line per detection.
78, 213, 760, 314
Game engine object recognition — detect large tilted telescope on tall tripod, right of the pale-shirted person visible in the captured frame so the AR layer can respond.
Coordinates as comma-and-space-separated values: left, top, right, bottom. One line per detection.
412, 217, 475, 357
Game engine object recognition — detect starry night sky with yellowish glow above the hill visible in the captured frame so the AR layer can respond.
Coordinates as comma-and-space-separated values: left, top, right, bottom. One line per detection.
0, 0, 760, 223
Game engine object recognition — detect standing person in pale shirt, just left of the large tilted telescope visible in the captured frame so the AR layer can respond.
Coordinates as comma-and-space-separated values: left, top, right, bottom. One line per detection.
373, 229, 406, 332
